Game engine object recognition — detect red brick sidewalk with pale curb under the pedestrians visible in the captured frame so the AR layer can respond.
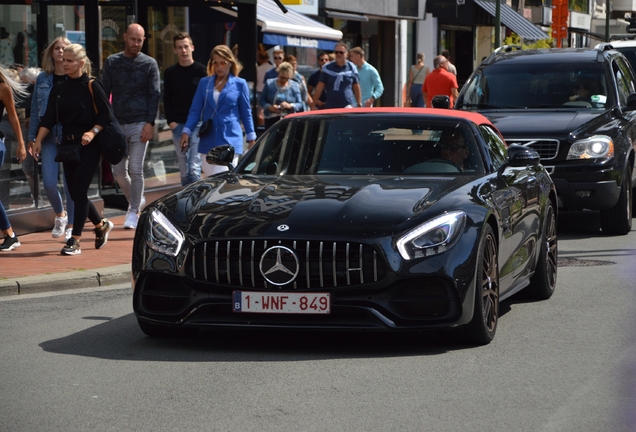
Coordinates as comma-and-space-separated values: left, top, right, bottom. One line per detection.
0, 211, 135, 296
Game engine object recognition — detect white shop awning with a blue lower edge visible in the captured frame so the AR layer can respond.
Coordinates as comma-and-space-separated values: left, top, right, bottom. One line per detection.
214, 0, 342, 51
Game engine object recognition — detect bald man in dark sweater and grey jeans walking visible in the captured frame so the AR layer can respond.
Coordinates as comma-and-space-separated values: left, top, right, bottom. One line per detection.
102, 23, 161, 229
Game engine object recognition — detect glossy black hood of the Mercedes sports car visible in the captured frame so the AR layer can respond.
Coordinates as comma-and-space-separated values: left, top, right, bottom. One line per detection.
161, 174, 470, 236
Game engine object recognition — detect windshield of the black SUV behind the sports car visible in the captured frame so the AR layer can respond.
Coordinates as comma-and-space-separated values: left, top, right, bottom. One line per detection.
458, 61, 609, 110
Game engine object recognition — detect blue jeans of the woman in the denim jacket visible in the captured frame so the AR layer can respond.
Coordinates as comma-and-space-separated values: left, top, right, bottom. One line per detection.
40, 134, 75, 225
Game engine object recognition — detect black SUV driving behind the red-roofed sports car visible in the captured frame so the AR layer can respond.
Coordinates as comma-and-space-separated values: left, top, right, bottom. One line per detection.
455, 44, 636, 235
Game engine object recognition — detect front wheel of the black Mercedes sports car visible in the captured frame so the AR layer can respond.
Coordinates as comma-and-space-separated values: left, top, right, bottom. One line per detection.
463, 225, 499, 345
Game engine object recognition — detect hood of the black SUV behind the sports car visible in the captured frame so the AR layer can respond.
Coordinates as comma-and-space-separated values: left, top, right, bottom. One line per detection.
481, 109, 606, 137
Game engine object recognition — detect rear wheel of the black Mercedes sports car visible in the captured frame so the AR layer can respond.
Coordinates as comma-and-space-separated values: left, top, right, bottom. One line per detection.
524, 201, 559, 300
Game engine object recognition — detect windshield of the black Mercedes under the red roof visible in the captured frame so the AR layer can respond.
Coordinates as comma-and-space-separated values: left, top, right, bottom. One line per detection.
237, 116, 484, 175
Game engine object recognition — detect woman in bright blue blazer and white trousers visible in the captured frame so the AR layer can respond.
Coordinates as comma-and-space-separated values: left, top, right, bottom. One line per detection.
181, 45, 256, 176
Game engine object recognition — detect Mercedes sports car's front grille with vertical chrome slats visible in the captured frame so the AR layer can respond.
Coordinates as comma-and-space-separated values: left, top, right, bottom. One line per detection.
186, 240, 386, 290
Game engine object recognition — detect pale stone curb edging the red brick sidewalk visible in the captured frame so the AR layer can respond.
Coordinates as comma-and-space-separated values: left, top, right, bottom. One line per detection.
0, 264, 131, 297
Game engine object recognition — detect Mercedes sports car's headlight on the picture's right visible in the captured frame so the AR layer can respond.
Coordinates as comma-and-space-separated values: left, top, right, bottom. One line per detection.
397, 211, 466, 260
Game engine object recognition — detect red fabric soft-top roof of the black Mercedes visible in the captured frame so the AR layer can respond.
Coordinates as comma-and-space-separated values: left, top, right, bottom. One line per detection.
285, 107, 496, 129
